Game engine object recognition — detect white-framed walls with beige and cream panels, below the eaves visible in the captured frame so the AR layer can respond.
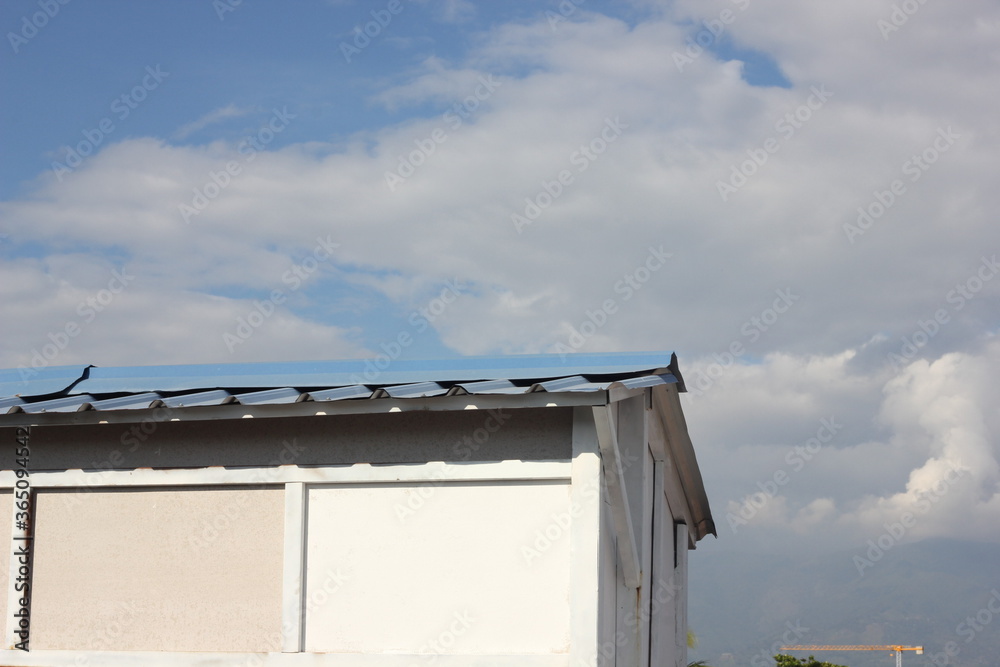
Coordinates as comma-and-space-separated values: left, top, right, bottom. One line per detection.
0, 396, 704, 667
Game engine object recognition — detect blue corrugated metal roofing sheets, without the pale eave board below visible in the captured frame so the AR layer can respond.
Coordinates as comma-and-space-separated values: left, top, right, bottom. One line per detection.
0, 352, 684, 414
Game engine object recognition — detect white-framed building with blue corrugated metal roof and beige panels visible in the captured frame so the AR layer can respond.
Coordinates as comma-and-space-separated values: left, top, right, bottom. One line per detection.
0, 352, 715, 667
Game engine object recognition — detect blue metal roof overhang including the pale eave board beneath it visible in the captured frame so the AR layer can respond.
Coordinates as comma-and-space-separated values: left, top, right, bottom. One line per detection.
0, 352, 683, 425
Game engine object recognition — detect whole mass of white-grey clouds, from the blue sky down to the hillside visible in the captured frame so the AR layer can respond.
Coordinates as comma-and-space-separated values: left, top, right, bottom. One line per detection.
0, 0, 1000, 541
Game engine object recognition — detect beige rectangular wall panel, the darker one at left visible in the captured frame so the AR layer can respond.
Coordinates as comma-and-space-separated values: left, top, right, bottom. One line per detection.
31, 488, 284, 651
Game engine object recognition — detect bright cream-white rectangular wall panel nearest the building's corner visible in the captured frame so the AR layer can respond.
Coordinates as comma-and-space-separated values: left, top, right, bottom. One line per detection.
305, 482, 571, 659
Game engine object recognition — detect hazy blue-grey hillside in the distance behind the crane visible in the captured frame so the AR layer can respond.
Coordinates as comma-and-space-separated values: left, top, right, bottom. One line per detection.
689, 540, 1000, 667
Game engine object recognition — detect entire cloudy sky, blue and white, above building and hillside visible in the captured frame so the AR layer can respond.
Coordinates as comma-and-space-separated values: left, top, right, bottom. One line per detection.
0, 0, 1000, 580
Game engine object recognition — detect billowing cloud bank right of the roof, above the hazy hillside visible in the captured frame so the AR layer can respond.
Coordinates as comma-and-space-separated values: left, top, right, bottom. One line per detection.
685, 340, 1000, 548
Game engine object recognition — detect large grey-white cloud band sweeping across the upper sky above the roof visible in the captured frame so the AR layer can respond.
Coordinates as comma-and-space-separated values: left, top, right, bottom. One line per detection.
2, 3, 998, 368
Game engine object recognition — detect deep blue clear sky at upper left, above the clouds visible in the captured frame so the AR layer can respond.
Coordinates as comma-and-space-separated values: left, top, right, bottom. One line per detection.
0, 0, 786, 197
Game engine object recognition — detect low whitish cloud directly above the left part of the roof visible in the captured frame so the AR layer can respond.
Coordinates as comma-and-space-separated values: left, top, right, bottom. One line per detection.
0, 256, 365, 374
